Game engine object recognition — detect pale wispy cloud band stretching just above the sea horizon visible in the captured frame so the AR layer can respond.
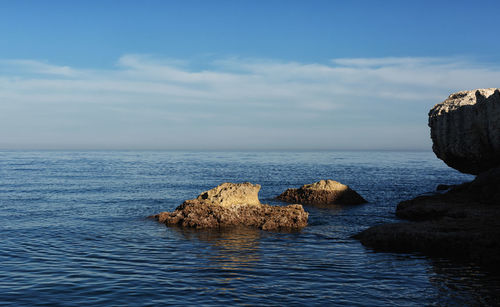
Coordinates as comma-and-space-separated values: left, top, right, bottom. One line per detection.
0, 55, 500, 148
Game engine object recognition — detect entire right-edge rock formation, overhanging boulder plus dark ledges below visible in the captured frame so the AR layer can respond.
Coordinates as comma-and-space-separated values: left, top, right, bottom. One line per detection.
354, 89, 500, 270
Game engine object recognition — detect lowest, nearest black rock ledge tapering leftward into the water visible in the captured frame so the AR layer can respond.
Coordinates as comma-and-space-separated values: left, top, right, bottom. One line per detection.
354, 218, 500, 270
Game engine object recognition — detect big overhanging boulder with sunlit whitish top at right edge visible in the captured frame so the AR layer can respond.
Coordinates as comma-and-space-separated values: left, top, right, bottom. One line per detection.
429, 88, 500, 175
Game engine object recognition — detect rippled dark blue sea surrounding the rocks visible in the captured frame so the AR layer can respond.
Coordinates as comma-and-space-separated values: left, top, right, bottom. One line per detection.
0, 151, 500, 306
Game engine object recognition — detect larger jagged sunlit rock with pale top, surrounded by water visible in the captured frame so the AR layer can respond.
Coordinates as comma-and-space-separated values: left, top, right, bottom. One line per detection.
151, 182, 308, 230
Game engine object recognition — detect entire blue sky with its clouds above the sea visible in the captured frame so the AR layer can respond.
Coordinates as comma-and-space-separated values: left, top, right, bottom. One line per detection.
0, 0, 500, 150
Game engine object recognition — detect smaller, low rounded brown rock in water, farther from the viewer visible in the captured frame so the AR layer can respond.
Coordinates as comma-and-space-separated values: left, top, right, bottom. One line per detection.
277, 180, 366, 206
